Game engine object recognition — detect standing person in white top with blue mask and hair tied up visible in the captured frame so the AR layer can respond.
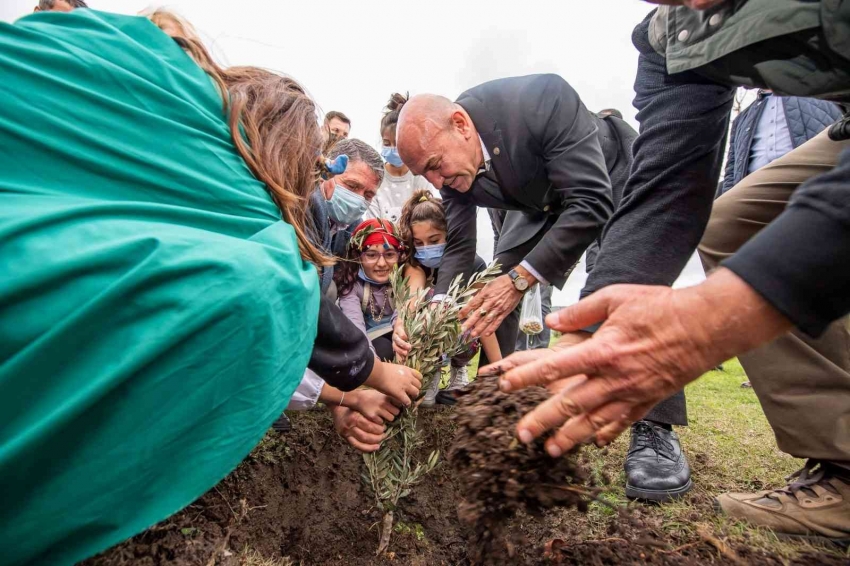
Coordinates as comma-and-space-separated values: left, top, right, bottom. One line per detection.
364, 93, 439, 223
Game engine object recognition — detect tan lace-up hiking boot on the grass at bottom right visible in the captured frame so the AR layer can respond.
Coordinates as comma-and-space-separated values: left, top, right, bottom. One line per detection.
715, 460, 850, 546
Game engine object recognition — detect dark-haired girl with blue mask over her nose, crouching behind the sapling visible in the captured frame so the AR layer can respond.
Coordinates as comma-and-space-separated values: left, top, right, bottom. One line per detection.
392, 190, 502, 406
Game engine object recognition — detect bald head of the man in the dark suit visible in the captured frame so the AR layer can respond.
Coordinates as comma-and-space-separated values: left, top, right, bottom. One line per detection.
396, 94, 483, 192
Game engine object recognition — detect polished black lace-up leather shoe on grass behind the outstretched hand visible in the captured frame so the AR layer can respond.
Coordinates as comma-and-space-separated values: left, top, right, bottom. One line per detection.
625, 421, 693, 502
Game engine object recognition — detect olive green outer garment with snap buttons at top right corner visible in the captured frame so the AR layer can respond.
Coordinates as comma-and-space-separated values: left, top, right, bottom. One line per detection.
649, 0, 850, 101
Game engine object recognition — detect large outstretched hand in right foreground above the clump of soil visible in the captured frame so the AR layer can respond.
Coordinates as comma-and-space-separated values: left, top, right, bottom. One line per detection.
476, 269, 791, 457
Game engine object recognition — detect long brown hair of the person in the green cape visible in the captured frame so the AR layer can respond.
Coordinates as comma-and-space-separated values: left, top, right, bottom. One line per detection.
146, 10, 333, 266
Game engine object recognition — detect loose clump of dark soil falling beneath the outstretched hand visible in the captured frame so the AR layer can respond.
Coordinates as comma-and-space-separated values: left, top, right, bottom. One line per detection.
449, 378, 597, 564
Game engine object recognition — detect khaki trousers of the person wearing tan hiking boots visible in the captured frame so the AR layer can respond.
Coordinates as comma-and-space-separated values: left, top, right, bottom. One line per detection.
699, 132, 850, 467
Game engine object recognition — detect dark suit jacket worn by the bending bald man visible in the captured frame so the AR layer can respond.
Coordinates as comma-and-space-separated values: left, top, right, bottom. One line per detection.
435, 75, 613, 294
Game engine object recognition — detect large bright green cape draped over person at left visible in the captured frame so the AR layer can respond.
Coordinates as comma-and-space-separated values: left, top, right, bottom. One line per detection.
0, 10, 319, 566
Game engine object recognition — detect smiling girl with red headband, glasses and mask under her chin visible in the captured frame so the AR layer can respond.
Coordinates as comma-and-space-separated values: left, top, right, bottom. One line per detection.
334, 220, 404, 361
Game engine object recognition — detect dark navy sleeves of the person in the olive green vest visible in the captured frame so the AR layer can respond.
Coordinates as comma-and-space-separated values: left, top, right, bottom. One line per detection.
582, 13, 850, 336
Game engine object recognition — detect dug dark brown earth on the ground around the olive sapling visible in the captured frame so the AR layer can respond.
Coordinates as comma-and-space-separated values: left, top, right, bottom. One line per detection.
83, 394, 846, 566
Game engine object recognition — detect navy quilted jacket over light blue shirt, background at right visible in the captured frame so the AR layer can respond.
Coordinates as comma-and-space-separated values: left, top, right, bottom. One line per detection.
717, 92, 841, 196
